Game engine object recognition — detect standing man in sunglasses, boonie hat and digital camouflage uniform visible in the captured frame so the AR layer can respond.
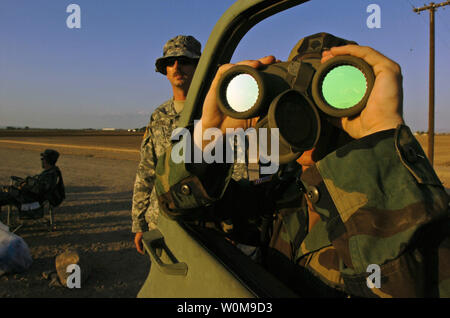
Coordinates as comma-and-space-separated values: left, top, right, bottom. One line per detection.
132, 35, 201, 253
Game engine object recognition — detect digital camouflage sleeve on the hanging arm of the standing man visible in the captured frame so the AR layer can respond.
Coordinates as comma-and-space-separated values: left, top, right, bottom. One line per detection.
131, 121, 157, 233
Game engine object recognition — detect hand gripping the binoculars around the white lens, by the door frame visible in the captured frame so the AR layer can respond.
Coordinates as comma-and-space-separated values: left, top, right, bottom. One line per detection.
201, 56, 276, 148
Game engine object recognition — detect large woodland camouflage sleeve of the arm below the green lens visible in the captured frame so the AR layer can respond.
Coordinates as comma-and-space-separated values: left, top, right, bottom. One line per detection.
301, 125, 450, 297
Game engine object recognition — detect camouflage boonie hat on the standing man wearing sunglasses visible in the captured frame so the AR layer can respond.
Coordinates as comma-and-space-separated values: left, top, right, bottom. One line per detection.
155, 35, 202, 75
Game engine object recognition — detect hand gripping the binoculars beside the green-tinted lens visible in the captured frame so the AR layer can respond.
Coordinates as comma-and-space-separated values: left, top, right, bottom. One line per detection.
322, 45, 403, 139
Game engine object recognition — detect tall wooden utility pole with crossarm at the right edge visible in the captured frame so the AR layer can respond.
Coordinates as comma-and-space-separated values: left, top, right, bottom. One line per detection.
413, 1, 450, 165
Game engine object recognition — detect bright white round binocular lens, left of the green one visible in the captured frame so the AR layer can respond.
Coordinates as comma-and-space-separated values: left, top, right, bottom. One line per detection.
226, 74, 259, 112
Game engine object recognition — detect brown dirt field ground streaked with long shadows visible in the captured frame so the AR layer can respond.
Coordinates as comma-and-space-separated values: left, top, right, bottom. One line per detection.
0, 135, 450, 298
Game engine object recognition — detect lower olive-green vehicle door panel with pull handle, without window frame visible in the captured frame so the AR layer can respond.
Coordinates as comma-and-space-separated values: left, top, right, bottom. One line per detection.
138, 217, 296, 298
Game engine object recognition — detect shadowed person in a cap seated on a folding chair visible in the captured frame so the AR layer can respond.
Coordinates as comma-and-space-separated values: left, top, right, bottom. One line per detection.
0, 149, 65, 207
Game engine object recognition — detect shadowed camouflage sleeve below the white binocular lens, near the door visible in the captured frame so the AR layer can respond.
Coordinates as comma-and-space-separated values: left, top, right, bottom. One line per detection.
155, 131, 261, 221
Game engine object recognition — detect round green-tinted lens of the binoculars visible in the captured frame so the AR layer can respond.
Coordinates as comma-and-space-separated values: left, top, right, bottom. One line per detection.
322, 65, 367, 109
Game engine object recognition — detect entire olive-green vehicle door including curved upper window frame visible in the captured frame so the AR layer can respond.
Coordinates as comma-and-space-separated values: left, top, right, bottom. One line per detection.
138, 0, 308, 298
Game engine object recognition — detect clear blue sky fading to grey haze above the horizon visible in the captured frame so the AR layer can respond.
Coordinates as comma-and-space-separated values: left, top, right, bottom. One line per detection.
0, 0, 450, 132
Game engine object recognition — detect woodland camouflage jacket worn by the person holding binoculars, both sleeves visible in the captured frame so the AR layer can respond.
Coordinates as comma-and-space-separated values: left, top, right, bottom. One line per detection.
156, 125, 450, 297
